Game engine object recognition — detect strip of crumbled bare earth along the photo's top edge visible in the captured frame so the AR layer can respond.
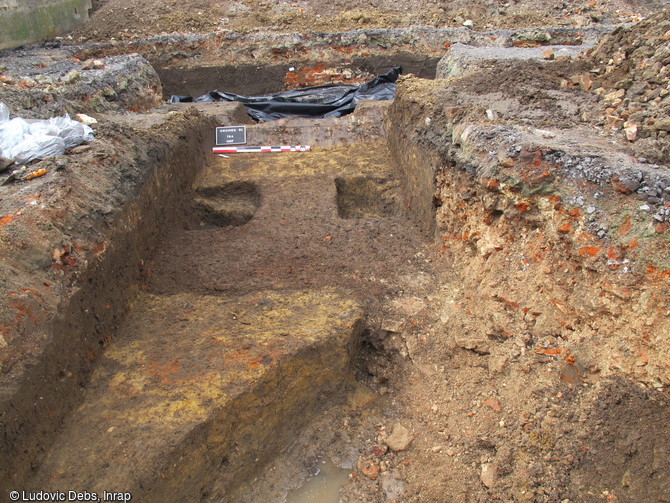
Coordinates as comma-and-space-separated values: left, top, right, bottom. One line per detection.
72, 0, 662, 42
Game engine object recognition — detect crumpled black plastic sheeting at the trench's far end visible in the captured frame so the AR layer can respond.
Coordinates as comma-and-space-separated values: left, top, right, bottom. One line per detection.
170, 66, 402, 122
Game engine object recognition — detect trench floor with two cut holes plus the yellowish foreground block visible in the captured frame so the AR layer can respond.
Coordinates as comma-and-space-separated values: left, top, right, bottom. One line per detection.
28, 143, 430, 501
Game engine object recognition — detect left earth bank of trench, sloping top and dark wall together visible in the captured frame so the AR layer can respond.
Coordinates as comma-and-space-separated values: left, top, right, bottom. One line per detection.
0, 112, 220, 491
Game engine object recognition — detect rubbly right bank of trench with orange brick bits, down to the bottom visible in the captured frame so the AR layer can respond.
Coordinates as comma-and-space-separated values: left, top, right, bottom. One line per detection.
336, 47, 670, 503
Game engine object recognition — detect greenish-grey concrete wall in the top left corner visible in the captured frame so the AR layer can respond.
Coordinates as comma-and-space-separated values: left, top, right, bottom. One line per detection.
0, 0, 92, 49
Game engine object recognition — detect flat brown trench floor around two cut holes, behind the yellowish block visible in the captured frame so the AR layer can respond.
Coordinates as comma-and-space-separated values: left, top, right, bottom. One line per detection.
150, 143, 428, 300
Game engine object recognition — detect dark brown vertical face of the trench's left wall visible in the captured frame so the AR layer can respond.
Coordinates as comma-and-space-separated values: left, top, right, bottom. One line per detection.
0, 110, 215, 494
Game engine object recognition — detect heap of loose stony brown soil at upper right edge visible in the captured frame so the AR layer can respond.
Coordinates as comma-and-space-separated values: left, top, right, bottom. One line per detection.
590, 9, 670, 164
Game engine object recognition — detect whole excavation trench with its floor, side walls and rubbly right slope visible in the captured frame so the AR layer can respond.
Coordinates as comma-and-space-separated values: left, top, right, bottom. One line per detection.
5, 43, 670, 503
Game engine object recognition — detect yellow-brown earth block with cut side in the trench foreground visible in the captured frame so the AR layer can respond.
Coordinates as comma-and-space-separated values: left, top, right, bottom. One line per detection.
31, 289, 363, 501
